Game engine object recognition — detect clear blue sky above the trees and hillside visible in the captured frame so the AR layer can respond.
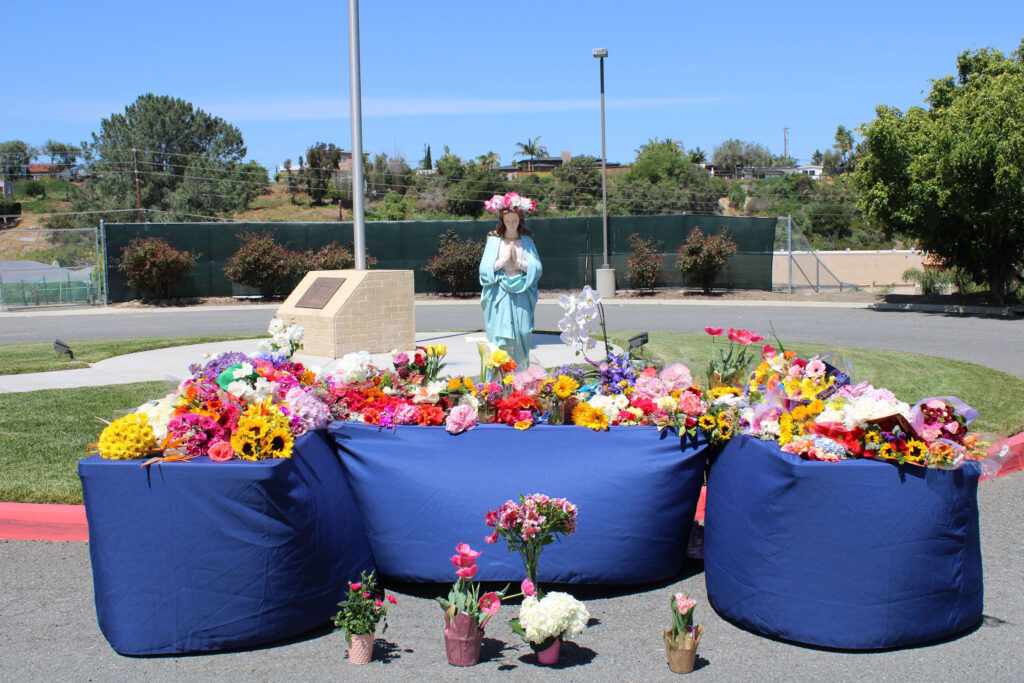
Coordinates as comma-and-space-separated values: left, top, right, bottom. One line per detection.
6, 0, 1024, 168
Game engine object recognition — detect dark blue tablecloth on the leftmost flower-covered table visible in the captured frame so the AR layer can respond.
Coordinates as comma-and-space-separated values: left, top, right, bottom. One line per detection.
79, 431, 373, 654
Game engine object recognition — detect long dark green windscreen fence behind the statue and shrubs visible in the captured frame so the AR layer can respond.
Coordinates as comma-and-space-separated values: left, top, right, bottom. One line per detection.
105, 215, 775, 301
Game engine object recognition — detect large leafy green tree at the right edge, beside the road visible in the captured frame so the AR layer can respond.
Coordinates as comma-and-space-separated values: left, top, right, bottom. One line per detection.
855, 41, 1024, 301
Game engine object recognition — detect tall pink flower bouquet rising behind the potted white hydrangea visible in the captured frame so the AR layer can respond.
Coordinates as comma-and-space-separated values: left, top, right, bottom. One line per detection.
483, 494, 578, 585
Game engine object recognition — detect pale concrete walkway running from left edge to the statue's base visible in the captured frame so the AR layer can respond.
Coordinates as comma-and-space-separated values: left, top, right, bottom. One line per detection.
0, 332, 596, 393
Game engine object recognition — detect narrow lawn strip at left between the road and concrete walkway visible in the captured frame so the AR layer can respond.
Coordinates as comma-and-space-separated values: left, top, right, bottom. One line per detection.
0, 334, 267, 375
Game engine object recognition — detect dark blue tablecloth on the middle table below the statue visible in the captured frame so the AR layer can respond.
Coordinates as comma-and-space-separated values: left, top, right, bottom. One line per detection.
330, 423, 707, 584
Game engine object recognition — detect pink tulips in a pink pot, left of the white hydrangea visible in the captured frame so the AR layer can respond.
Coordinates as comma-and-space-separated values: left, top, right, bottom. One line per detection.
437, 543, 508, 667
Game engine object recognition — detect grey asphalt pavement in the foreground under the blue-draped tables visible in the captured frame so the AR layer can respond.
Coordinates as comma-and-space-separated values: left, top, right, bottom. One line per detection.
0, 474, 1024, 683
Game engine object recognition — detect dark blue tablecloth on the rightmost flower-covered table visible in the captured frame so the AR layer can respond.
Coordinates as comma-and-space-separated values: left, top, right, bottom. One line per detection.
705, 437, 983, 649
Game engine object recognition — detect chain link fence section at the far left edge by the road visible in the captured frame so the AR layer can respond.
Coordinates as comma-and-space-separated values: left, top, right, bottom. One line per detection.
0, 227, 105, 310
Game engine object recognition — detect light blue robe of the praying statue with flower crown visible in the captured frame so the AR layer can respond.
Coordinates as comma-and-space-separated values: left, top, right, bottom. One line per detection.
480, 234, 542, 370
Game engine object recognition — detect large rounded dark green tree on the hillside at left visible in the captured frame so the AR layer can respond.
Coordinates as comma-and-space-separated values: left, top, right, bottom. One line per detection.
82, 93, 246, 220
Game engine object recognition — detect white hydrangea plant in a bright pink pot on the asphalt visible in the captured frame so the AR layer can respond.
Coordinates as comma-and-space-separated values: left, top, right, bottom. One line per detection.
509, 579, 590, 665
